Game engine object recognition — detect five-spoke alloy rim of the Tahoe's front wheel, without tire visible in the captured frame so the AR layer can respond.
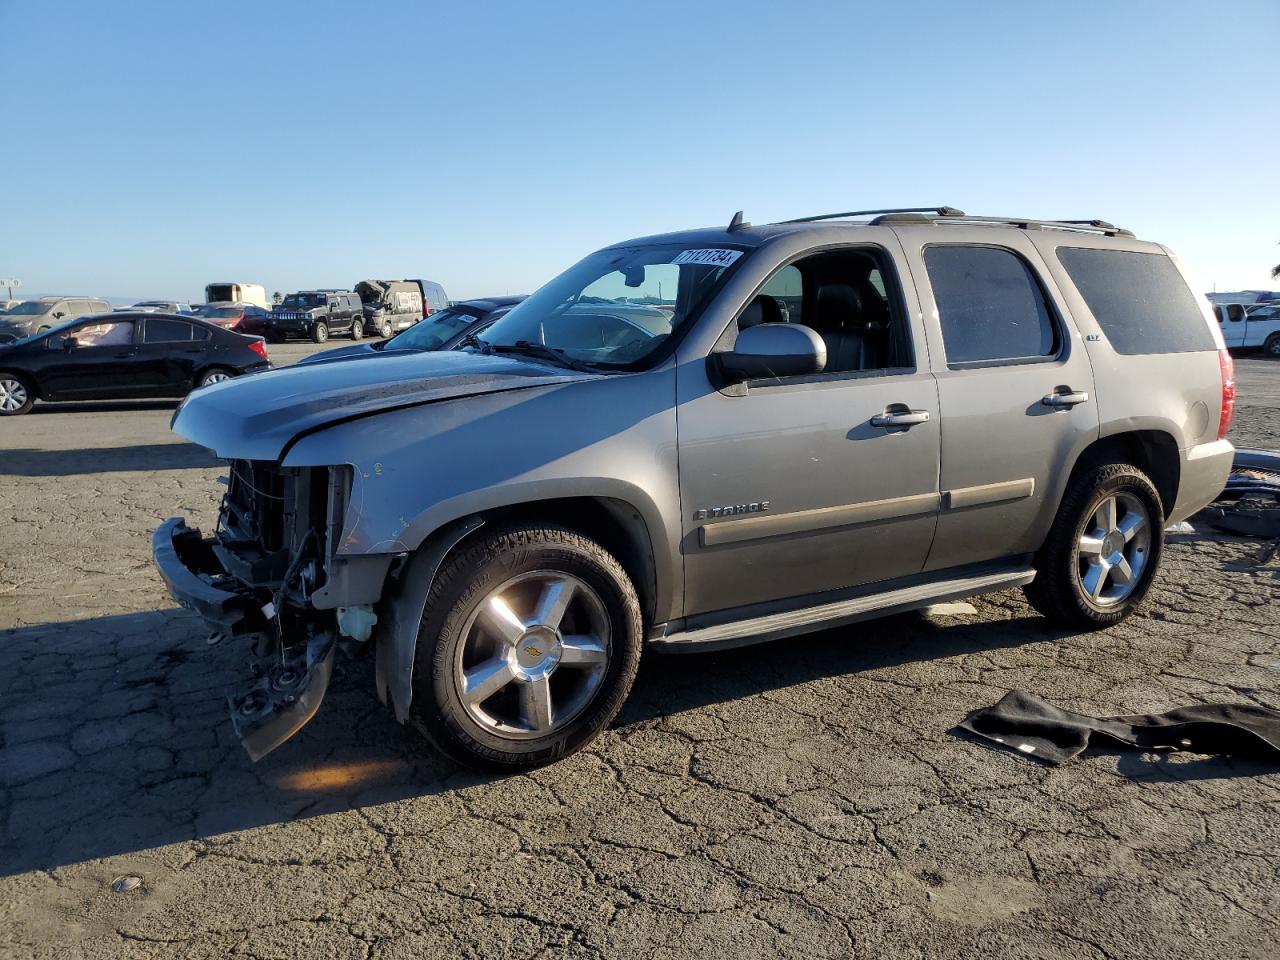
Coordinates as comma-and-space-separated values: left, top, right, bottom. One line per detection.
453, 570, 609, 740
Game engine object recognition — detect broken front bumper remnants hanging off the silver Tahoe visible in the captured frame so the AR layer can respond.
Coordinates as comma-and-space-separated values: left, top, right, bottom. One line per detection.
151, 517, 335, 760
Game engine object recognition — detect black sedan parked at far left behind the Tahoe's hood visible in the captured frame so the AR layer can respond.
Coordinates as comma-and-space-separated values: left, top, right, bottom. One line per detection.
0, 312, 270, 416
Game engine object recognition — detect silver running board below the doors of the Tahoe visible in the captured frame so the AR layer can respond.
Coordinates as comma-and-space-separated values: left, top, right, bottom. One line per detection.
649, 567, 1036, 653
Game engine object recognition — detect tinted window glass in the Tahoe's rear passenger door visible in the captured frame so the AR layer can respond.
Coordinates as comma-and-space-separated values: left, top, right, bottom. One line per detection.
924, 243, 1060, 366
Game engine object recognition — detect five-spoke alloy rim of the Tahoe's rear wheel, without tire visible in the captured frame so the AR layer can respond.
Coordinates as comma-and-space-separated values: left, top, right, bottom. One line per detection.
1076, 493, 1151, 607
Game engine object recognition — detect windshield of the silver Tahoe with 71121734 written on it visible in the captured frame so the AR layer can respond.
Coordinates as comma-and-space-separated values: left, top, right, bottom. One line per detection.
484, 243, 742, 369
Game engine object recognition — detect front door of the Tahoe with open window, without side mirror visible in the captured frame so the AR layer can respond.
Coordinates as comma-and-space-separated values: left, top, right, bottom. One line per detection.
677, 246, 941, 616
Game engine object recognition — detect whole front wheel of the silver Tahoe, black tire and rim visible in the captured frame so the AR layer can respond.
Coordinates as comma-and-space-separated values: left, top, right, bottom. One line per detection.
410, 525, 643, 771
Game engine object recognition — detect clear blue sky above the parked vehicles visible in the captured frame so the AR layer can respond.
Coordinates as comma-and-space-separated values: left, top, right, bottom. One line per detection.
0, 0, 1280, 300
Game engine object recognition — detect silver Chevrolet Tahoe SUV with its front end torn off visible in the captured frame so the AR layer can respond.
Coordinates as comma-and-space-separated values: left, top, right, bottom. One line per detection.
154, 207, 1234, 769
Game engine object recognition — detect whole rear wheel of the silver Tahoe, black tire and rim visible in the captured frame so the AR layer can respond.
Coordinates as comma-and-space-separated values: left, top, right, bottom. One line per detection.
1023, 463, 1165, 630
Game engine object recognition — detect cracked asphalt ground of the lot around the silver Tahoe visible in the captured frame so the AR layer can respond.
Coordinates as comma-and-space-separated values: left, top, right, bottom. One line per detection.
0, 347, 1280, 960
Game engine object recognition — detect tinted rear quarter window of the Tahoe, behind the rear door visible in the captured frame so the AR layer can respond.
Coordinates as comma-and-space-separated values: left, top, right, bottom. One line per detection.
1057, 247, 1217, 355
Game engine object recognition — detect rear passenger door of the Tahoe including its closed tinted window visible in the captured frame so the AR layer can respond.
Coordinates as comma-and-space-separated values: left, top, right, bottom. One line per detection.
900, 225, 1098, 570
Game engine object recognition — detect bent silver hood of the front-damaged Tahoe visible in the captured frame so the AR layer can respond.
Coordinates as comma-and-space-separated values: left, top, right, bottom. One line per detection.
173, 351, 599, 461
